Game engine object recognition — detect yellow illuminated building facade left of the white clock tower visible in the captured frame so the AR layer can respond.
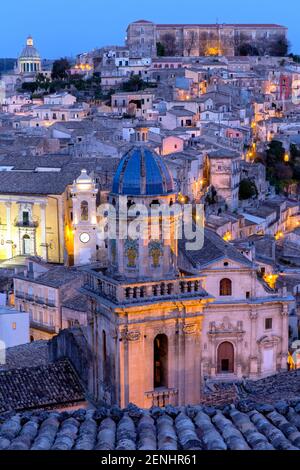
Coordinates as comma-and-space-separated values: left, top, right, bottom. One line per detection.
0, 192, 73, 264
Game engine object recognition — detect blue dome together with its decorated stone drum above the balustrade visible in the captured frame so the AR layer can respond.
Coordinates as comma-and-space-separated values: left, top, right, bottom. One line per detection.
109, 145, 178, 279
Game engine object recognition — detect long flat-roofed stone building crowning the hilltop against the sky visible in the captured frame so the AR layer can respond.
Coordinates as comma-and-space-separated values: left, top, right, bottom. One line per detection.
127, 20, 287, 57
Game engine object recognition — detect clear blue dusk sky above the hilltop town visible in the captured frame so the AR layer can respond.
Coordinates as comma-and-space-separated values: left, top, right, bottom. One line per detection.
0, 0, 300, 58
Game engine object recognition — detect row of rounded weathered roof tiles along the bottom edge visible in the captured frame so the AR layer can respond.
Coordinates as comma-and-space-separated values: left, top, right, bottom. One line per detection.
0, 402, 300, 451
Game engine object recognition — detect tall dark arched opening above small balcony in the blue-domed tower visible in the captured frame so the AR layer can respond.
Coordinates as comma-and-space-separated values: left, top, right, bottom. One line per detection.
154, 335, 168, 388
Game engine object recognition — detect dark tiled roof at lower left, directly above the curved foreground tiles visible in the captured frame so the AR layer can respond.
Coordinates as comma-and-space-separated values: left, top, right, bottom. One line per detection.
0, 359, 84, 413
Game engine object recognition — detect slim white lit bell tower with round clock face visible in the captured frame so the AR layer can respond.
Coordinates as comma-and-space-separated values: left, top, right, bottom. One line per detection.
71, 170, 98, 266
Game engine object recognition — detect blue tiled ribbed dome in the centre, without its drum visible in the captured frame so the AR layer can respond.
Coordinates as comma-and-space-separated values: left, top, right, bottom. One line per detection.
112, 146, 175, 196
